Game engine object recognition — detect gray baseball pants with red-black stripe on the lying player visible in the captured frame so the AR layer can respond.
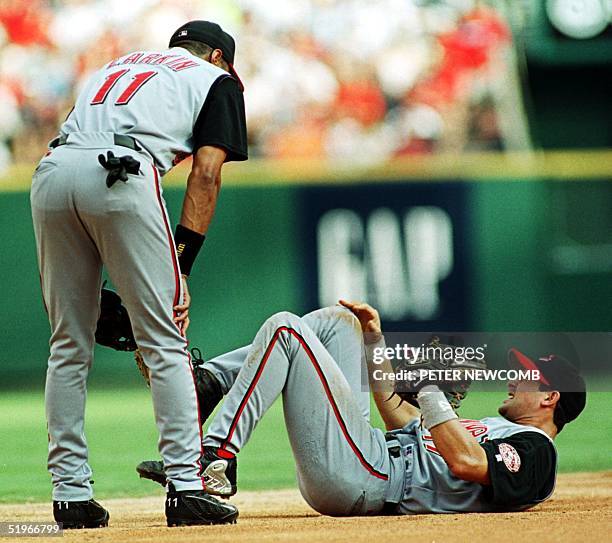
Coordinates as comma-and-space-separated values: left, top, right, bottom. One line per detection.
204, 306, 403, 516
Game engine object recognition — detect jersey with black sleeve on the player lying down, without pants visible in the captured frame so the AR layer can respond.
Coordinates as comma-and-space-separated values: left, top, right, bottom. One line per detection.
387, 417, 556, 514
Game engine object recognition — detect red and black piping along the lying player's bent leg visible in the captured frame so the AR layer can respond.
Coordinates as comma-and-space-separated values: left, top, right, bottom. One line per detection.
220, 326, 389, 481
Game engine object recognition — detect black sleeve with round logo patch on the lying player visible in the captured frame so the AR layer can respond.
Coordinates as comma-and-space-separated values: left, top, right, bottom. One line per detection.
482, 431, 557, 508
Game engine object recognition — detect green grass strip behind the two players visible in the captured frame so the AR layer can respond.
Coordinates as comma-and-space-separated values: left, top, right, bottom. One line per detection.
0, 388, 612, 503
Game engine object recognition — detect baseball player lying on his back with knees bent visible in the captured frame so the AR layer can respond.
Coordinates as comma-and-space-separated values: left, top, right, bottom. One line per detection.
137, 302, 586, 516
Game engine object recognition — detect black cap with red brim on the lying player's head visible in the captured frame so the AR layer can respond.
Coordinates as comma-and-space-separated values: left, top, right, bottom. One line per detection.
508, 348, 586, 424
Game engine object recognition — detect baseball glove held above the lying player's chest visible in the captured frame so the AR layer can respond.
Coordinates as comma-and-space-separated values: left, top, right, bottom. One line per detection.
394, 336, 487, 410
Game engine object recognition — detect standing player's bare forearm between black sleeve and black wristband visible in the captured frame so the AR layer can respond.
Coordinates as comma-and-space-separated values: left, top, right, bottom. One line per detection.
180, 170, 221, 234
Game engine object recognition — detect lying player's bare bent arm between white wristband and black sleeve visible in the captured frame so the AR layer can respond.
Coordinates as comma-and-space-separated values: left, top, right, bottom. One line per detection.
429, 419, 489, 484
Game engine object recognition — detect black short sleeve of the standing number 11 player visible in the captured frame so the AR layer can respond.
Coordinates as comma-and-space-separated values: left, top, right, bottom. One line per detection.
193, 76, 248, 162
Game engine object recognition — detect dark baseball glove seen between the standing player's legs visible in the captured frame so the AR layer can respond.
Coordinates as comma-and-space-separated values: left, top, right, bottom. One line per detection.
96, 287, 137, 351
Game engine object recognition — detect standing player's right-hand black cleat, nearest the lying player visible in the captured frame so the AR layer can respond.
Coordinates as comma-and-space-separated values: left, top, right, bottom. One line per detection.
166, 484, 238, 526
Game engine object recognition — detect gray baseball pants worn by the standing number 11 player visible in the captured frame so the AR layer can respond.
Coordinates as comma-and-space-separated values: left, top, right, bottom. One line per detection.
31, 132, 203, 501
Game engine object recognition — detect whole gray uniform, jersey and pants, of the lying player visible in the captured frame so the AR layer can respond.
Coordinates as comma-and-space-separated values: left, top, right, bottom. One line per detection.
204, 306, 556, 515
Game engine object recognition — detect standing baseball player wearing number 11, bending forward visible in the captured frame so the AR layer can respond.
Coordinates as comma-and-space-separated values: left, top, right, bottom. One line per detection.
31, 21, 247, 528
